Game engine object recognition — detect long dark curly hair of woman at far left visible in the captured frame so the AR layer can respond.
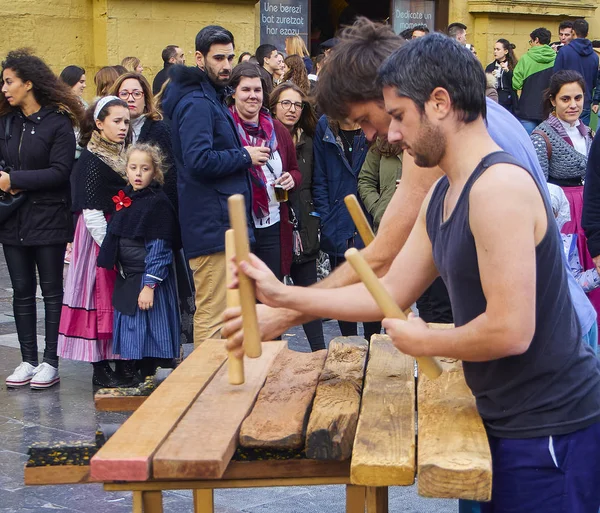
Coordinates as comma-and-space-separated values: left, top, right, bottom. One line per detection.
0, 48, 83, 126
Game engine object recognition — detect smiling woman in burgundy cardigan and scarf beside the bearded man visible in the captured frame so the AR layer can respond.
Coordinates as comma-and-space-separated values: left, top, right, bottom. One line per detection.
229, 62, 301, 280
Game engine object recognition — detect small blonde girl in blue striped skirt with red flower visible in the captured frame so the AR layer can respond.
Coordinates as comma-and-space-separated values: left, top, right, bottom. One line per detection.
98, 144, 180, 378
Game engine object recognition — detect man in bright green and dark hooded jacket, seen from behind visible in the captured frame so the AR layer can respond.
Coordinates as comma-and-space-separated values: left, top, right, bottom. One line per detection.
512, 28, 556, 135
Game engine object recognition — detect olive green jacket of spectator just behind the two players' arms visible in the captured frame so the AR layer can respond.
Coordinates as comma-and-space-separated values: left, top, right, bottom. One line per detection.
358, 146, 402, 232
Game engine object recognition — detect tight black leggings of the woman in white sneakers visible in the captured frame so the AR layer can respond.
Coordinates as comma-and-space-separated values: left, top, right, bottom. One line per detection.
3, 244, 67, 367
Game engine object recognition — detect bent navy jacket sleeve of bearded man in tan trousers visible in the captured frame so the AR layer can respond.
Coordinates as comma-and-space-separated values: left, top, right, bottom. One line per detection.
178, 101, 252, 179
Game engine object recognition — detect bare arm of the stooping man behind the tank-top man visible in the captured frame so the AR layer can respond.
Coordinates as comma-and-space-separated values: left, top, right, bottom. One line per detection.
223, 152, 442, 344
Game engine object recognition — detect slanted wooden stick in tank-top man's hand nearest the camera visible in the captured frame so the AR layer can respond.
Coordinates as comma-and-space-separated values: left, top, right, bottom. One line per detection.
344, 248, 442, 379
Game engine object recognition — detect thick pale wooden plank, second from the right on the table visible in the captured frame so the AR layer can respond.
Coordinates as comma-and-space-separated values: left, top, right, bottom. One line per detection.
350, 335, 416, 486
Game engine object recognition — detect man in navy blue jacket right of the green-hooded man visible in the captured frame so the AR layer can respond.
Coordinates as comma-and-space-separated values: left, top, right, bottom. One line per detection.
554, 20, 598, 125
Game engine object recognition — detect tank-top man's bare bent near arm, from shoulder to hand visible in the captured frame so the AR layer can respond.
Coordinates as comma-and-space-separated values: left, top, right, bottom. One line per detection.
384, 165, 540, 361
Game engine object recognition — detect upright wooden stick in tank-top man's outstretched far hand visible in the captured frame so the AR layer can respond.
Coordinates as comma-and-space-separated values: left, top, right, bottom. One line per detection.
228, 194, 262, 358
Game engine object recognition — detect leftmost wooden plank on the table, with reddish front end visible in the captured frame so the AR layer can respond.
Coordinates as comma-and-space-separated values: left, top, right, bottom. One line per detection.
91, 340, 227, 481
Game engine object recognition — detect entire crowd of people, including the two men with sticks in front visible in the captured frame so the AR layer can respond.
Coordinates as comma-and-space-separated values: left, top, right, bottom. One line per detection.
0, 14, 600, 512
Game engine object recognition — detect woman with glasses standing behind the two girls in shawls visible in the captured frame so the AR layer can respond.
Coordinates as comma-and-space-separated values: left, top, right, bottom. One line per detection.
111, 72, 194, 344
